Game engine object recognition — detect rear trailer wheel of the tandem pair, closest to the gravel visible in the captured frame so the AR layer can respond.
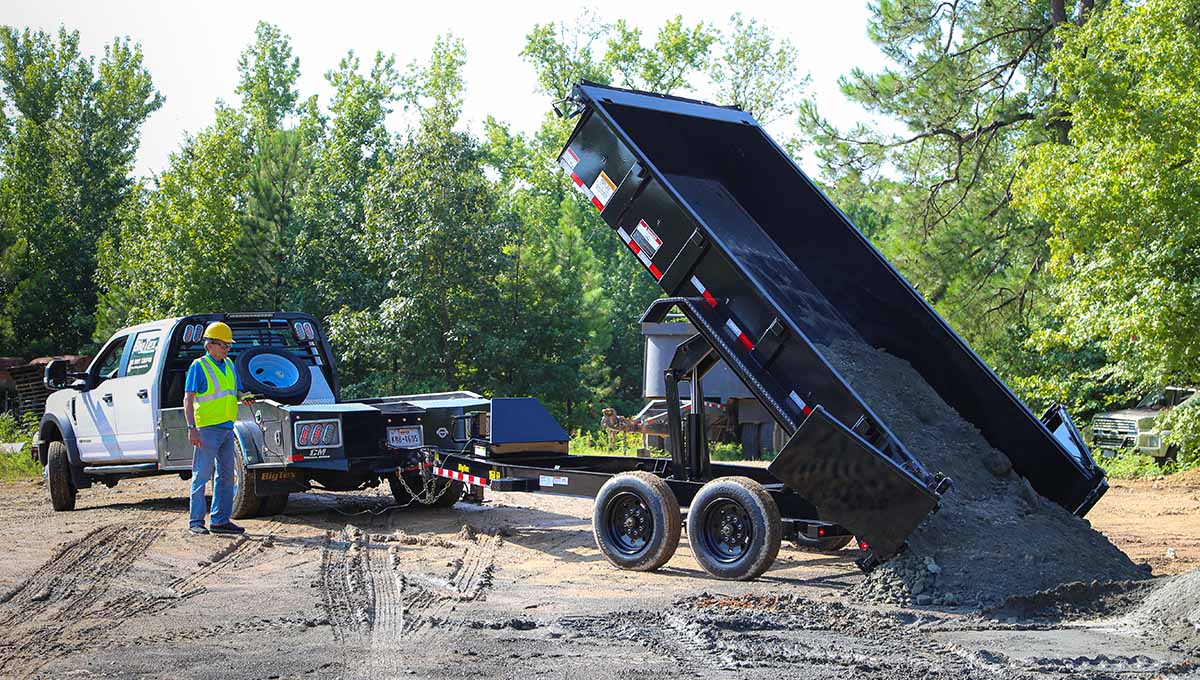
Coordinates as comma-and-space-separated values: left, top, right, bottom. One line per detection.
688, 477, 782, 580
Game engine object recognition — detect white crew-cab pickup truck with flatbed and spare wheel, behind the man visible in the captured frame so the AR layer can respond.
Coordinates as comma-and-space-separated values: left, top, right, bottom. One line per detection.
32, 312, 490, 518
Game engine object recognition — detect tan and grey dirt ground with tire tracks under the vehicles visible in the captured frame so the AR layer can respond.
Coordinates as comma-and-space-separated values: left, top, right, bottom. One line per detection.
0, 477, 1200, 680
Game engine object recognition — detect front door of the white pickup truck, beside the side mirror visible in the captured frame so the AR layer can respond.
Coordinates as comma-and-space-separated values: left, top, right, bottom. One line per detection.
74, 336, 130, 463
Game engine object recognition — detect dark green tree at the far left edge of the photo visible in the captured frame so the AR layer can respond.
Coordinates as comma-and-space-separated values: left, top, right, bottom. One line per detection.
0, 26, 162, 355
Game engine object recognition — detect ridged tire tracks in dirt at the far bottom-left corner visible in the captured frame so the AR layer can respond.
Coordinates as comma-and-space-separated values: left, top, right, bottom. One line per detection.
0, 520, 167, 676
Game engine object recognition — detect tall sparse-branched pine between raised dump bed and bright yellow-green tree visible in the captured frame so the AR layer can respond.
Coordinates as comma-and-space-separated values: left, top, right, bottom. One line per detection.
800, 0, 1123, 403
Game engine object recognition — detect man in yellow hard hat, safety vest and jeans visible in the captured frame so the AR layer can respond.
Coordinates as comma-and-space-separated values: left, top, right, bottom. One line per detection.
184, 321, 253, 534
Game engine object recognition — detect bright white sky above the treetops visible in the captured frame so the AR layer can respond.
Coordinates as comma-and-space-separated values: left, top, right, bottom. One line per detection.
7, 0, 886, 176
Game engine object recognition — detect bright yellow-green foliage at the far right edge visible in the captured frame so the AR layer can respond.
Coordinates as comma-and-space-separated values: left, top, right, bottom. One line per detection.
1015, 0, 1200, 385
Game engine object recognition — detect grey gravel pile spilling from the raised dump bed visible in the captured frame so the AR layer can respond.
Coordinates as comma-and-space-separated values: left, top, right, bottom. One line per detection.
818, 343, 1148, 607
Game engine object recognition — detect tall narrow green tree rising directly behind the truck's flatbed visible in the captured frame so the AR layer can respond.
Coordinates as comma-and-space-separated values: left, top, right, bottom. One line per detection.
330, 37, 505, 391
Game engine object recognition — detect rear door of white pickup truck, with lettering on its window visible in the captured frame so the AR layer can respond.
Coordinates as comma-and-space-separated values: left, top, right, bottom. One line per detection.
110, 329, 163, 463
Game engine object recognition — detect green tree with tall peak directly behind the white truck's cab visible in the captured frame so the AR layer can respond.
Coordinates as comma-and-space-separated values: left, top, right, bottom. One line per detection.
96, 24, 300, 328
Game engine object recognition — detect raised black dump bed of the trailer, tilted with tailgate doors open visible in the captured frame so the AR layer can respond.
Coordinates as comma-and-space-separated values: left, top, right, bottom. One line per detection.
554, 83, 1108, 568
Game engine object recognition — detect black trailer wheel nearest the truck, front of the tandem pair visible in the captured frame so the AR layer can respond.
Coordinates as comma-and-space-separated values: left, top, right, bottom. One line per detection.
592, 471, 683, 571
